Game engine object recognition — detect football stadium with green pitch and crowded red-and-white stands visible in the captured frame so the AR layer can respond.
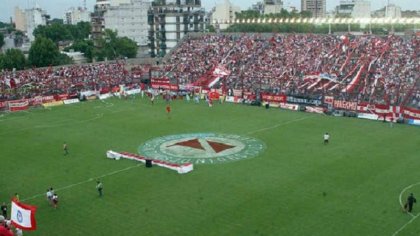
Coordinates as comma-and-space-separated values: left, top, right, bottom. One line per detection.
0, 1, 420, 236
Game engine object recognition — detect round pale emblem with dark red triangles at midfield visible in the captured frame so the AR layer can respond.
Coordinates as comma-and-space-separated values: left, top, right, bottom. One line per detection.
139, 133, 265, 164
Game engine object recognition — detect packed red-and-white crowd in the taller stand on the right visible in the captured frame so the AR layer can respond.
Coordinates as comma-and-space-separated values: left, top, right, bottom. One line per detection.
163, 34, 420, 107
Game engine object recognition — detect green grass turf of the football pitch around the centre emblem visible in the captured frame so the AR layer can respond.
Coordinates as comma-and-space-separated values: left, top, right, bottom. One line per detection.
0, 99, 420, 236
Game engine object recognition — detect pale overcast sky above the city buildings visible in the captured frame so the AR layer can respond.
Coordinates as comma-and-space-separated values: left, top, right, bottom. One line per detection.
0, 0, 420, 21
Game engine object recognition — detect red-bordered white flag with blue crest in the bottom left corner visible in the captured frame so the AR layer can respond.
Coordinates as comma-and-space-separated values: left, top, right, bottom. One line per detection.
10, 199, 36, 230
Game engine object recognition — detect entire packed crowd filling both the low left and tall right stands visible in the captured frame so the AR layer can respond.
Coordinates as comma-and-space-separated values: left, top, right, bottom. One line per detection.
0, 34, 420, 108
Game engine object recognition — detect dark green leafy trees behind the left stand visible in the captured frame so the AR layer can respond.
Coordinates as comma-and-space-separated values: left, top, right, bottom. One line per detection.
0, 21, 137, 70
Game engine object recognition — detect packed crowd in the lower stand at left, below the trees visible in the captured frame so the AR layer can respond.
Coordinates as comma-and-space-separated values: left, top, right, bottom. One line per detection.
0, 63, 133, 100
